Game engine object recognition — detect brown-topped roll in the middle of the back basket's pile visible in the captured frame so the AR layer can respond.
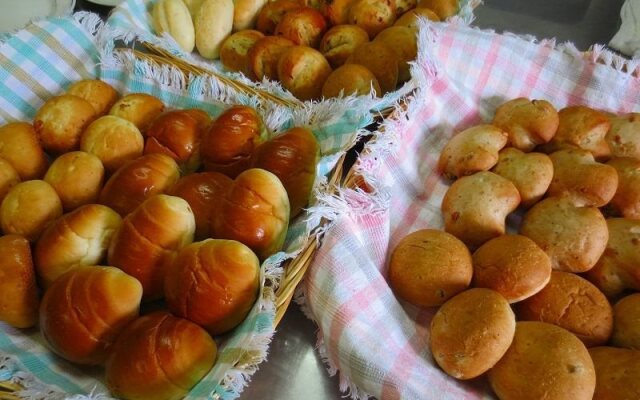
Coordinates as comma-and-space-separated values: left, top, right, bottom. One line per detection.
318, 24, 369, 68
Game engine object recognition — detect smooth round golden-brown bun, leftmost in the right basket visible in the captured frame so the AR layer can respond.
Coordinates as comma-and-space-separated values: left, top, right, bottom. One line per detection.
389, 229, 473, 307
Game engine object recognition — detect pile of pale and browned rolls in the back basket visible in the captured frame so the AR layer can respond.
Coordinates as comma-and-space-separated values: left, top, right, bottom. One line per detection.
152, 0, 459, 100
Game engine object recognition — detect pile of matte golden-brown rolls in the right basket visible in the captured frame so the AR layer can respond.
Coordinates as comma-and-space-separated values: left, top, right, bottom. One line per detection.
389, 98, 640, 400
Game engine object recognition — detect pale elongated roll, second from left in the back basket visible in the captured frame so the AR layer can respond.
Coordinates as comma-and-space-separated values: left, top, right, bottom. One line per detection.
194, 0, 234, 59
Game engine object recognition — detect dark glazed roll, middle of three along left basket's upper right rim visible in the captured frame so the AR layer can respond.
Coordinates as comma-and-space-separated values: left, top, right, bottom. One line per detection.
200, 106, 266, 178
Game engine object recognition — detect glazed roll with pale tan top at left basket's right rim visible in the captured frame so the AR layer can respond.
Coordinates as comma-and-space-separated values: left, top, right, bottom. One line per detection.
214, 168, 289, 260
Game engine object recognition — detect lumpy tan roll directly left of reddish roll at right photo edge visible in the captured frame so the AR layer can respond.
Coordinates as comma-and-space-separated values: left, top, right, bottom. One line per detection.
547, 149, 618, 207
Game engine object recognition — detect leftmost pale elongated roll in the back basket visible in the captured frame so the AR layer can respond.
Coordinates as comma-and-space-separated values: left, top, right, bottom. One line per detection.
151, 0, 196, 53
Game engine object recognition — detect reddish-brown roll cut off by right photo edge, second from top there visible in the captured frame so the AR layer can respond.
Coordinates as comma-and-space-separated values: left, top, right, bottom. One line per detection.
607, 157, 640, 219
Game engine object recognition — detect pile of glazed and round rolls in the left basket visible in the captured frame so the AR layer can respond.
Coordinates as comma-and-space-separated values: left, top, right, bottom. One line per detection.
0, 79, 320, 400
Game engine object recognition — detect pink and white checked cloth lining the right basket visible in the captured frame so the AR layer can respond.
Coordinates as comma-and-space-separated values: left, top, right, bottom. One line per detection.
299, 21, 640, 400
